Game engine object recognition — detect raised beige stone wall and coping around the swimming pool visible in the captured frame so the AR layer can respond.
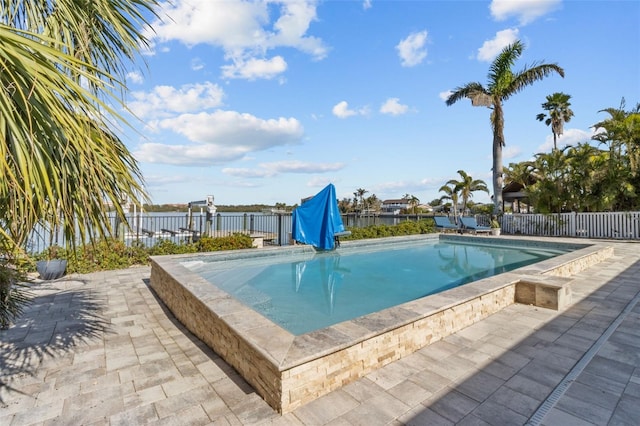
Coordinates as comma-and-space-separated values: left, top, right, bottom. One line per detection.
151, 235, 613, 413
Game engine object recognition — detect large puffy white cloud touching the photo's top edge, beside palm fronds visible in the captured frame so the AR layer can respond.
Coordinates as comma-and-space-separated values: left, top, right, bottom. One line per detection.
146, 0, 328, 79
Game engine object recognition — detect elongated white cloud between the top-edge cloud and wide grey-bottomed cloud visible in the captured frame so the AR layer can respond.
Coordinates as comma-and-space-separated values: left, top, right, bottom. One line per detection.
127, 82, 224, 118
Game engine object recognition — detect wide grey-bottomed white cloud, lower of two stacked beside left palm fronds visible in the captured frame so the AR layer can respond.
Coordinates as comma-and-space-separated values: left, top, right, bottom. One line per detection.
135, 111, 304, 166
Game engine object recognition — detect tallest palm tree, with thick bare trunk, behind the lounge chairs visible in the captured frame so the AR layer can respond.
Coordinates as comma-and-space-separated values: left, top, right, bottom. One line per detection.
446, 40, 564, 214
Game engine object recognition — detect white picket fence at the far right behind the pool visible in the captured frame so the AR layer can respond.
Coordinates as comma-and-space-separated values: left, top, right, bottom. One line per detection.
501, 212, 640, 240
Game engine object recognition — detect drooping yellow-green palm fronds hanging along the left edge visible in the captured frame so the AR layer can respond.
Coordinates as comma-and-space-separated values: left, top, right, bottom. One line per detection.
0, 0, 157, 320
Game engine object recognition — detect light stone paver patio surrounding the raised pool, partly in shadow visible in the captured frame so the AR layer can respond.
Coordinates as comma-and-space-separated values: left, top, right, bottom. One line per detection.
0, 238, 640, 425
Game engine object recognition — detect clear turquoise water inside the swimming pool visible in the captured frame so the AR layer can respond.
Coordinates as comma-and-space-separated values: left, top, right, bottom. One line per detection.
183, 240, 569, 335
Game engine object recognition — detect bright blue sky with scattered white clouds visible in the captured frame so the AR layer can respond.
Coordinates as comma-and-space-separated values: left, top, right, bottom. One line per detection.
123, 0, 640, 205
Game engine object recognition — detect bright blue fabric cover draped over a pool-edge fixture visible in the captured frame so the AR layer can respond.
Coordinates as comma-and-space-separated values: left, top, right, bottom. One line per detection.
291, 183, 345, 250
